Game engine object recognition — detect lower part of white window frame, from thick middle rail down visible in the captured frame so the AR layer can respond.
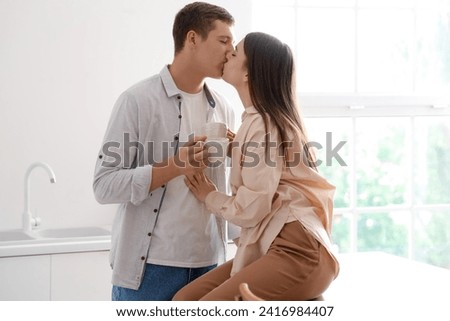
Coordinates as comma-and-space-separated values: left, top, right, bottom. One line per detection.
298, 94, 450, 259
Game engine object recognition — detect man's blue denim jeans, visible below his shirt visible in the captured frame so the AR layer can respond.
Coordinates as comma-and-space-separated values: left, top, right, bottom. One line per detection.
112, 264, 217, 301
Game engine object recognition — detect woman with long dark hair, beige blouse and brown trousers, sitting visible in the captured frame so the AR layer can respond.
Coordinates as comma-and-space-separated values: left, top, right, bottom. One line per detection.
174, 33, 339, 301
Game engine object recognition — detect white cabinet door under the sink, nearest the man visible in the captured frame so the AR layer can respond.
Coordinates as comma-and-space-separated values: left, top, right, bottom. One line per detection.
51, 251, 112, 301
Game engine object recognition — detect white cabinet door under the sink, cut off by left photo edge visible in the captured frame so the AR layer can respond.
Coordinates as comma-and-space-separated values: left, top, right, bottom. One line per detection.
0, 255, 50, 301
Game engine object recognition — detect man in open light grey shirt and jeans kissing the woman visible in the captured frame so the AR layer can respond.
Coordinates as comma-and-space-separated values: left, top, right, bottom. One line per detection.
93, 2, 234, 301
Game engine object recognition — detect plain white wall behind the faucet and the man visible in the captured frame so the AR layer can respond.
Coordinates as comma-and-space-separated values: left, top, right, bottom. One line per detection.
0, 0, 251, 229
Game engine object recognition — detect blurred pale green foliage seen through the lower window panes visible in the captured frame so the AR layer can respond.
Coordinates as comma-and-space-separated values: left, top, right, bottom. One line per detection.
319, 117, 450, 268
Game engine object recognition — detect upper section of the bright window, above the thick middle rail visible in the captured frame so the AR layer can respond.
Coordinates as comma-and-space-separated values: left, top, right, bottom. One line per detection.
252, 0, 450, 95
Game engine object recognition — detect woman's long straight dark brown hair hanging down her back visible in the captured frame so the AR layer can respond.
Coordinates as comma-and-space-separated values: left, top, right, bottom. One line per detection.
244, 32, 317, 169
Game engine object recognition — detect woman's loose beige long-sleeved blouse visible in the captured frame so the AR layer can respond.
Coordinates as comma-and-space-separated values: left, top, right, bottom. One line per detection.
205, 107, 338, 275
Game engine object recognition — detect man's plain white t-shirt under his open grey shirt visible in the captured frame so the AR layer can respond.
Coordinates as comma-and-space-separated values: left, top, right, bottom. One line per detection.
147, 90, 221, 267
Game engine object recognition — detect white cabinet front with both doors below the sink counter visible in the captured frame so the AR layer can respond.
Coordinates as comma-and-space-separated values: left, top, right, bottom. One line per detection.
0, 251, 112, 301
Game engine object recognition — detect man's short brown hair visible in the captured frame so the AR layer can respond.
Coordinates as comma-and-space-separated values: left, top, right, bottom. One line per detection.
172, 2, 234, 54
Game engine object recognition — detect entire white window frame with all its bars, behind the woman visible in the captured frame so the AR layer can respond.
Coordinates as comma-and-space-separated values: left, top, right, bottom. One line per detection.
252, 0, 450, 259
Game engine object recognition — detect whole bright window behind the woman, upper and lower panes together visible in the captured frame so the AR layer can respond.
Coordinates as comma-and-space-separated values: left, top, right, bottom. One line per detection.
252, 0, 450, 268
